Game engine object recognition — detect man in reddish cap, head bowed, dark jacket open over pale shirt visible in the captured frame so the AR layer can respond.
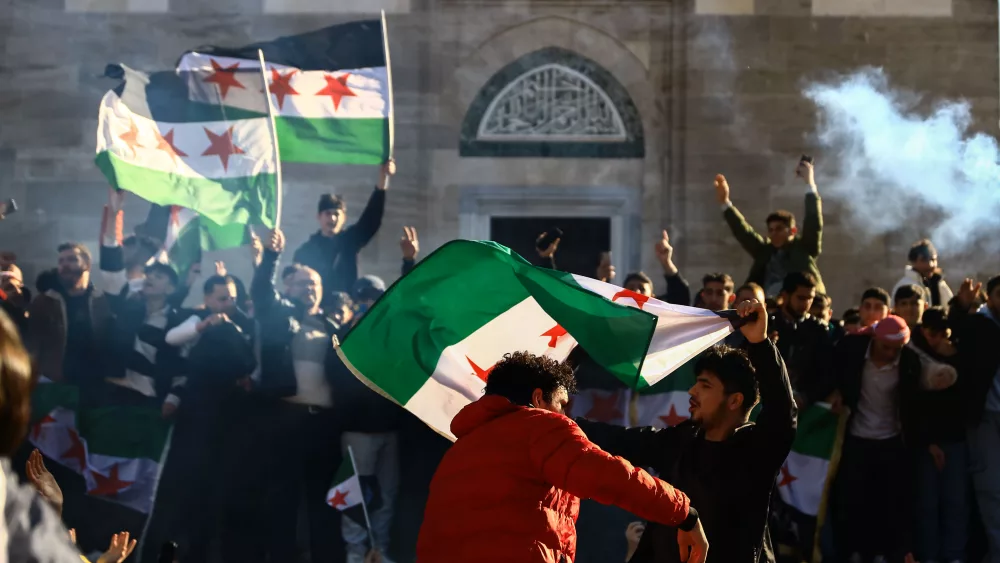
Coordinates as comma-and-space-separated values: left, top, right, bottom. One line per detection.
832, 315, 921, 561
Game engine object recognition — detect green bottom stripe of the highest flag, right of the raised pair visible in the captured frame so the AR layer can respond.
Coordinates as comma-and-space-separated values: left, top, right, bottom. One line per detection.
275, 116, 389, 164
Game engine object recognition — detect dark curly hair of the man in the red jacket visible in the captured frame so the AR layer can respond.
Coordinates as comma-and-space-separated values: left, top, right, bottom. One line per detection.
486, 352, 576, 406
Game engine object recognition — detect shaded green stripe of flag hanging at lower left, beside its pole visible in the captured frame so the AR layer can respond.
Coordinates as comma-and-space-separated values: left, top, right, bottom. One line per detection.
77, 406, 170, 463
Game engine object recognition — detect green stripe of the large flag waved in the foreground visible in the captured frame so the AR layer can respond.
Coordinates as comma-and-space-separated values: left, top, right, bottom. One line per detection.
341, 240, 656, 404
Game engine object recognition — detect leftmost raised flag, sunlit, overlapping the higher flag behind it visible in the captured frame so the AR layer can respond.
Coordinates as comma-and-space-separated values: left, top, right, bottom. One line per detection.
96, 65, 277, 232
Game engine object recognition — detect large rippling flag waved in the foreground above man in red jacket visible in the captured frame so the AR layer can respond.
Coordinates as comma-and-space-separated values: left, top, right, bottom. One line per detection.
339, 241, 733, 442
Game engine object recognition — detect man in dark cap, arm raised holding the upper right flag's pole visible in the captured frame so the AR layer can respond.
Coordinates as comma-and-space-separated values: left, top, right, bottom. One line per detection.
294, 159, 396, 308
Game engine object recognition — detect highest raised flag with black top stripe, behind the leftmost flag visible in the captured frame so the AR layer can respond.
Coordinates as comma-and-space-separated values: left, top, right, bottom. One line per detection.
177, 20, 391, 164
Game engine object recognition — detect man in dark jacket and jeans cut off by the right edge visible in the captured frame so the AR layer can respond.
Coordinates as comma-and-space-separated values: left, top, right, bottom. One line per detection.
950, 275, 1000, 563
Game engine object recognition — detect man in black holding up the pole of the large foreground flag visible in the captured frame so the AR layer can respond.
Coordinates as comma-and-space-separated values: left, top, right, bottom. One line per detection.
577, 300, 796, 563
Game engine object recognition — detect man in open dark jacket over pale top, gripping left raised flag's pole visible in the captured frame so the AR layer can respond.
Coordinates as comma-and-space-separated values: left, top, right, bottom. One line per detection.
250, 229, 344, 562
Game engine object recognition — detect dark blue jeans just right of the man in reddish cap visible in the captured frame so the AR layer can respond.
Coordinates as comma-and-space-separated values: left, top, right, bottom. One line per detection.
915, 442, 970, 561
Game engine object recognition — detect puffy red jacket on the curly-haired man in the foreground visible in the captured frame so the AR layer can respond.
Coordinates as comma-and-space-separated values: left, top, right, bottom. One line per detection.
417, 395, 689, 563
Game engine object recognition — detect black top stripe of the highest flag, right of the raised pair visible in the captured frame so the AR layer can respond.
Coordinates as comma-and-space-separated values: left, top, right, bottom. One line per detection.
182, 20, 385, 70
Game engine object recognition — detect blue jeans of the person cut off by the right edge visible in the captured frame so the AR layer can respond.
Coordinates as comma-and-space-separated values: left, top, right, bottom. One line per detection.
969, 411, 1000, 563
